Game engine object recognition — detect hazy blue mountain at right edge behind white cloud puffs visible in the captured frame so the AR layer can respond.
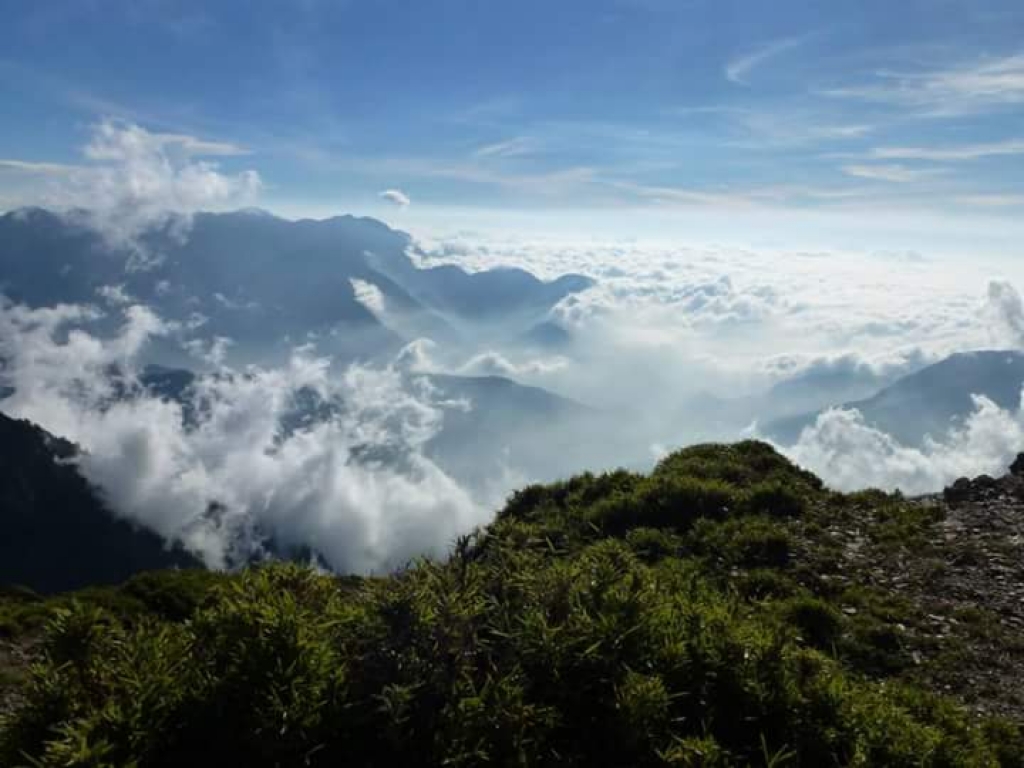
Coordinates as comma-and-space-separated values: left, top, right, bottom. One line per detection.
761, 350, 1024, 445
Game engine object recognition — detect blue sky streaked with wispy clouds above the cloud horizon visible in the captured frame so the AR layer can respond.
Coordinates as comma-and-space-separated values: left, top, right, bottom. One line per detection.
0, 0, 1024, 234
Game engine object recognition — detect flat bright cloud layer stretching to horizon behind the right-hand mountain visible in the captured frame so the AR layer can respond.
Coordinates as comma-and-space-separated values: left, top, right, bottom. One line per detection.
407, 228, 997, 423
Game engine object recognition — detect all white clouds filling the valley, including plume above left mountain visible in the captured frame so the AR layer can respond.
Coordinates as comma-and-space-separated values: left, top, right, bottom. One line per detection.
6, 124, 1024, 572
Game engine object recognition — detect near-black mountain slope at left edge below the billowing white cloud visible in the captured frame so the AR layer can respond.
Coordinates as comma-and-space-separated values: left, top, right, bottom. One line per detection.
0, 414, 200, 592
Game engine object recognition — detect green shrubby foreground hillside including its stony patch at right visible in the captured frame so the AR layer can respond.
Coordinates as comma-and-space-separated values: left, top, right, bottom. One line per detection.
0, 442, 1024, 767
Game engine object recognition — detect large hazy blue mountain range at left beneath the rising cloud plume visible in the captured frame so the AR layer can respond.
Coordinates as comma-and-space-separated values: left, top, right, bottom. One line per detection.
0, 209, 592, 364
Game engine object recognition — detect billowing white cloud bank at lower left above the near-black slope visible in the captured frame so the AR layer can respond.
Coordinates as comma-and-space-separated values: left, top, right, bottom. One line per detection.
0, 296, 484, 572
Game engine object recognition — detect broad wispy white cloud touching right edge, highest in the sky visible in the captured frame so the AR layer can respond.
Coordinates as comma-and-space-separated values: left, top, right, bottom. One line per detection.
821, 53, 1024, 117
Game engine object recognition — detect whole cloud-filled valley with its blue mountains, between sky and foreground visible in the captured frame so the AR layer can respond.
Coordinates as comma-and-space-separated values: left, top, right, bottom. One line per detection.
0, 121, 1024, 572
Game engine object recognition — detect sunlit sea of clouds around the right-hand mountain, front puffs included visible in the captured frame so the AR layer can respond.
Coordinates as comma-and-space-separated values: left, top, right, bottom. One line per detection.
407, 228, 1024, 494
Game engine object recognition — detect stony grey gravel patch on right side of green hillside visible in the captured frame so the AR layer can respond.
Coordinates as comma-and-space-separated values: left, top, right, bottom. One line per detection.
803, 462, 1024, 722
